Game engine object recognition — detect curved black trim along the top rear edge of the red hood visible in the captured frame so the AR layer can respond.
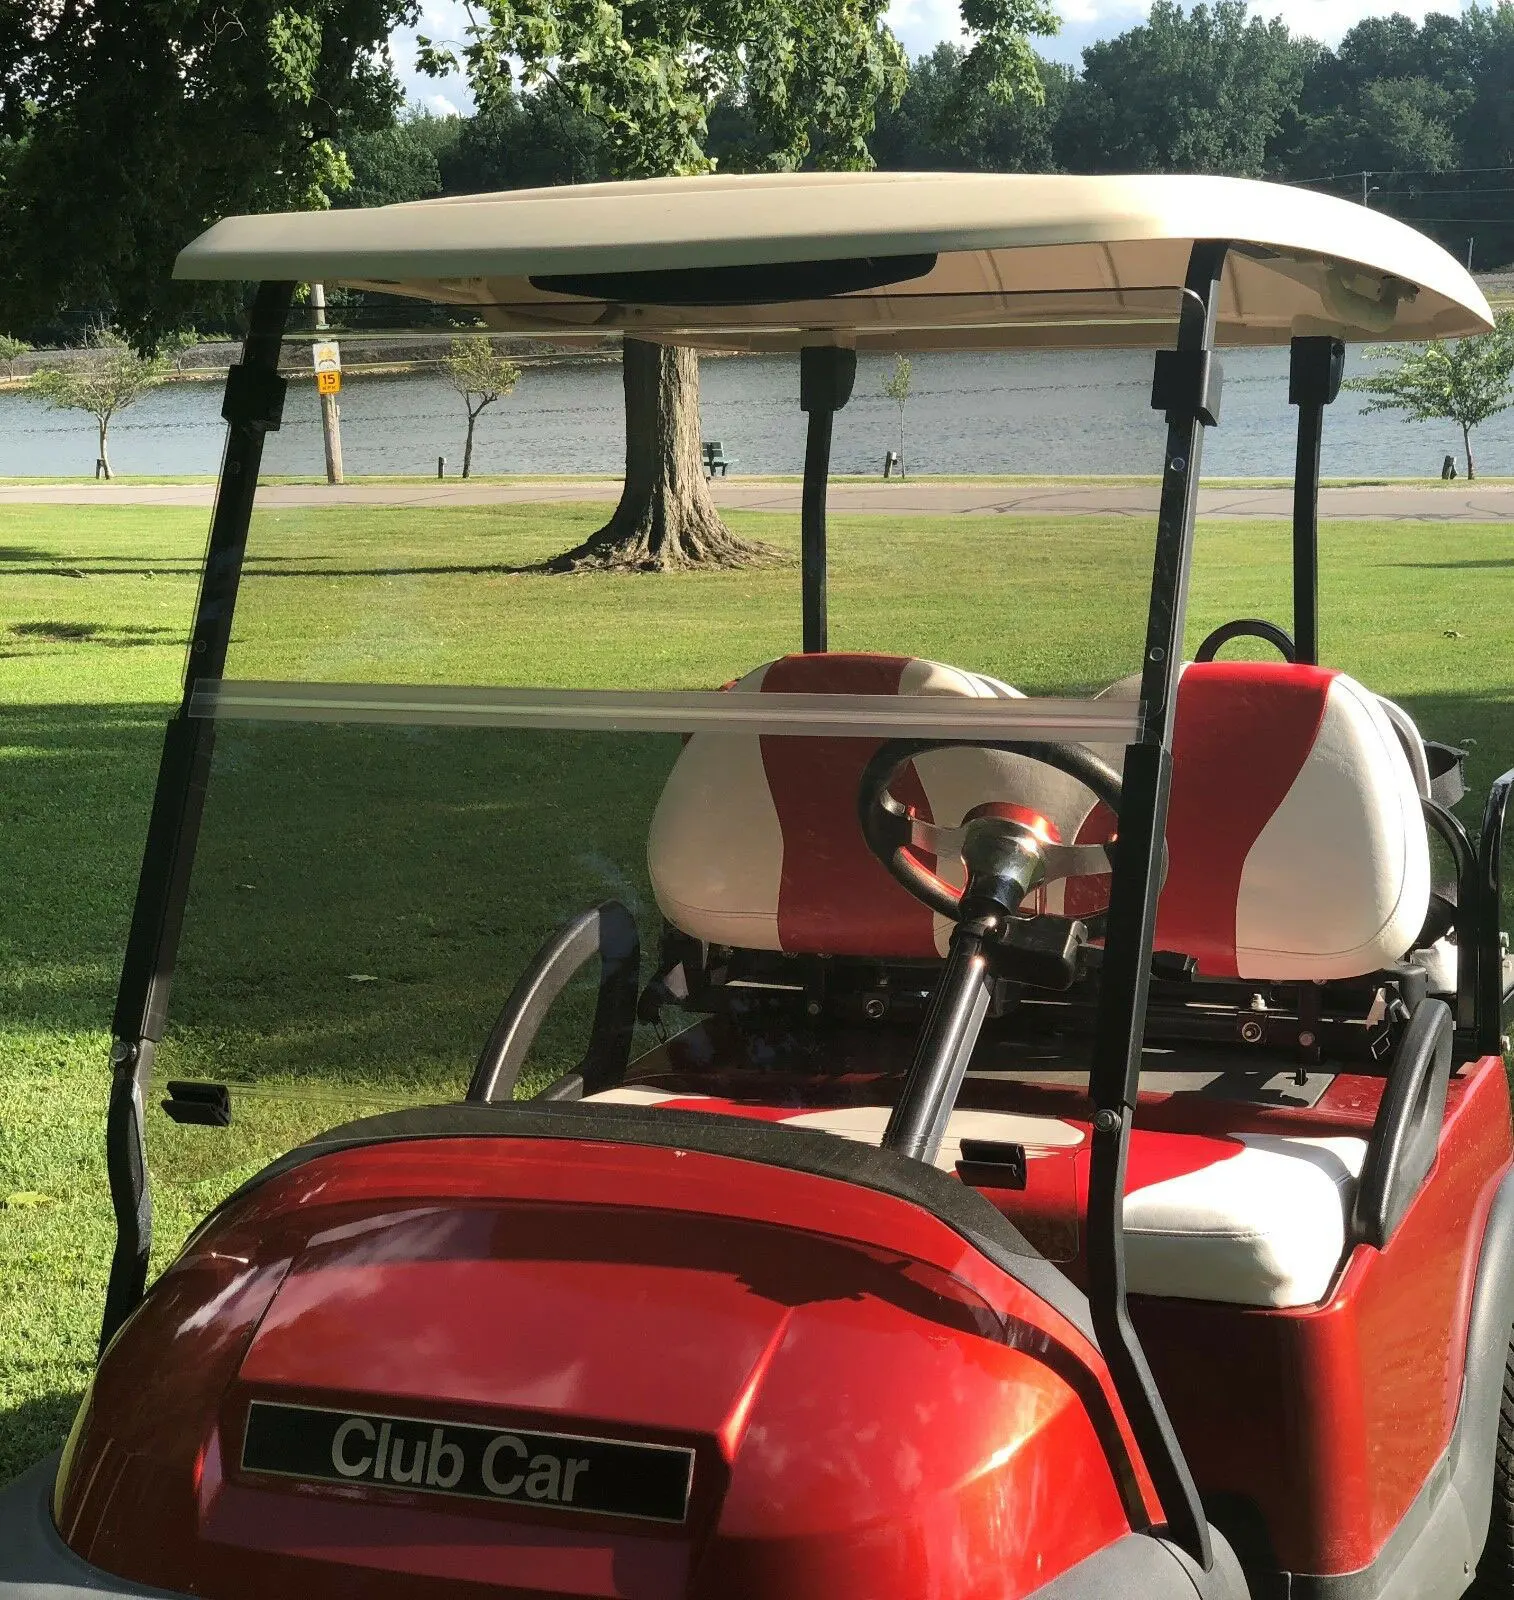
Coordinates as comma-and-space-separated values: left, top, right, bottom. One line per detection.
218, 1101, 1093, 1341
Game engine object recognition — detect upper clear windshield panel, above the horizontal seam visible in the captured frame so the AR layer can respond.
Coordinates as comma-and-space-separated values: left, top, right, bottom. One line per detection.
226, 328, 1164, 696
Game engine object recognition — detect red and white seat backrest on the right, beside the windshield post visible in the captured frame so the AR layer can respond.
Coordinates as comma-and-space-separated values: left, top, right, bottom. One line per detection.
1053, 661, 1431, 982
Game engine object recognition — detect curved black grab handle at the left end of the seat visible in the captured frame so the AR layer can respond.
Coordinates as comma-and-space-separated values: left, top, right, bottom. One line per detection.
466, 901, 642, 1106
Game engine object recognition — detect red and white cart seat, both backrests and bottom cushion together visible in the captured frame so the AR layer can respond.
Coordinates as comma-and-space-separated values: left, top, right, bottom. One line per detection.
633, 656, 1431, 1307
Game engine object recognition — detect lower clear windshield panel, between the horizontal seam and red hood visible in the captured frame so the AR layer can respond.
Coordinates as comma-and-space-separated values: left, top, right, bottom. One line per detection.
149, 690, 1107, 1254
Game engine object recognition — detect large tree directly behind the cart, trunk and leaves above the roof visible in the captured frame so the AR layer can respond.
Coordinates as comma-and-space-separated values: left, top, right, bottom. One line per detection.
421, 0, 1056, 571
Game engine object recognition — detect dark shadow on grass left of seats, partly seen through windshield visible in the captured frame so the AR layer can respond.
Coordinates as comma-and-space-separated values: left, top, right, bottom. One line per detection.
0, 706, 679, 1094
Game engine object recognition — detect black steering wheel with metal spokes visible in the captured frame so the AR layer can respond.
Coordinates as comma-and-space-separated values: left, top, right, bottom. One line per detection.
856, 739, 1120, 922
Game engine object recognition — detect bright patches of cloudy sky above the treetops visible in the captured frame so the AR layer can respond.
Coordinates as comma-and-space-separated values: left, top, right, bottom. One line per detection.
391, 0, 1458, 114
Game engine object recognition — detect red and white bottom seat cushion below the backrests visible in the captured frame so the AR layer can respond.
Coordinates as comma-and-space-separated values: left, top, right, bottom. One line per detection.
595, 1086, 1367, 1309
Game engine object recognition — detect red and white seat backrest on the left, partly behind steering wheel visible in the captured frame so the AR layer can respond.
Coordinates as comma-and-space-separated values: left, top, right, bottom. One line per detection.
647, 651, 1072, 960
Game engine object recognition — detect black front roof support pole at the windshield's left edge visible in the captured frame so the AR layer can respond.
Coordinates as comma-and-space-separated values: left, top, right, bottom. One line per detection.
99, 283, 294, 1350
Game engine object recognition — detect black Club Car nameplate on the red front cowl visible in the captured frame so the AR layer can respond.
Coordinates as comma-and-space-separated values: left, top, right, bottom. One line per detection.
242, 1400, 695, 1522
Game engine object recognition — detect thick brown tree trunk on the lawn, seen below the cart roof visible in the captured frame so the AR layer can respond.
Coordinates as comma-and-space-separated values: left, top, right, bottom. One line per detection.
551, 339, 787, 573
